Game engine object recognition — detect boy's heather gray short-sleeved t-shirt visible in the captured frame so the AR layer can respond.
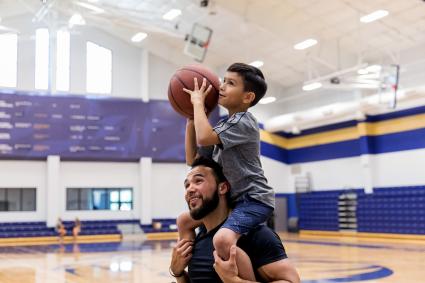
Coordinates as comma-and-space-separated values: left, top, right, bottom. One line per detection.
198, 112, 275, 208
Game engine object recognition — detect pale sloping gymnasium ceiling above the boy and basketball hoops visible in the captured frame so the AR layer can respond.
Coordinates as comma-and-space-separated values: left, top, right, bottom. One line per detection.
0, 0, 425, 130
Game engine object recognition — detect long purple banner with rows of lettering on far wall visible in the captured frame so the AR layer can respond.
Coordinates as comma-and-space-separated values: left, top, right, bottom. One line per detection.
0, 92, 195, 162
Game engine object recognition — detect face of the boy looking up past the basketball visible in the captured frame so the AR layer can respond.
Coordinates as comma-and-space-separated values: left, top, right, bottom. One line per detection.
218, 72, 252, 110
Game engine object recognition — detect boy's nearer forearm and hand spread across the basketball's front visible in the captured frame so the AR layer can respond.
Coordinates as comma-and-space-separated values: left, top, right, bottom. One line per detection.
183, 78, 220, 146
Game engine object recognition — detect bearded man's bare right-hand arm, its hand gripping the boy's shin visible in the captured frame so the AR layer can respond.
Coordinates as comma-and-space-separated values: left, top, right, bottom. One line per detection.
214, 246, 301, 283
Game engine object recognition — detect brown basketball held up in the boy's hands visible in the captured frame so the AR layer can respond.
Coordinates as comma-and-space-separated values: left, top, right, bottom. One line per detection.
168, 65, 220, 118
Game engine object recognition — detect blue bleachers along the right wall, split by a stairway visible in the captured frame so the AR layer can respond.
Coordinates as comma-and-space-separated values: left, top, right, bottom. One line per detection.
298, 186, 425, 235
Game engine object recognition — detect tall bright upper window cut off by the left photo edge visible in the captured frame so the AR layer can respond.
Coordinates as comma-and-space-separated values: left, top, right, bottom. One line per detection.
0, 33, 18, 87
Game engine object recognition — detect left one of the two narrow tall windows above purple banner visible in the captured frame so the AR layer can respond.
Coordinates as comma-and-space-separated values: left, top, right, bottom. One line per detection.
35, 28, 49, 89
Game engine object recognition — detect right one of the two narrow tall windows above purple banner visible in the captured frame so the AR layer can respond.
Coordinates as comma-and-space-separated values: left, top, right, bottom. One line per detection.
56, 30, 70, 91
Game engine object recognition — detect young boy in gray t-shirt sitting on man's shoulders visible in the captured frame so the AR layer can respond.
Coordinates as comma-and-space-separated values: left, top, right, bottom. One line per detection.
177, 63, 274, 260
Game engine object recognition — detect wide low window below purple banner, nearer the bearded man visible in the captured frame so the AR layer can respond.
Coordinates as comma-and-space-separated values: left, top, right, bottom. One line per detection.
66, 188, 133, 211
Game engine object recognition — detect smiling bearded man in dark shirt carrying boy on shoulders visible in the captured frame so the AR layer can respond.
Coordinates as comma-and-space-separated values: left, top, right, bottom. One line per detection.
169, 157, 300, 283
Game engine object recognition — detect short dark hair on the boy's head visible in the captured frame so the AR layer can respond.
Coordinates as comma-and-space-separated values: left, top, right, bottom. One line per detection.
227, 63, 267, 106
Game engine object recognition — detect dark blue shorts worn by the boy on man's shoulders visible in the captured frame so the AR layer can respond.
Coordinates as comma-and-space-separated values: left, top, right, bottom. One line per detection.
221, 196, 274, 235
